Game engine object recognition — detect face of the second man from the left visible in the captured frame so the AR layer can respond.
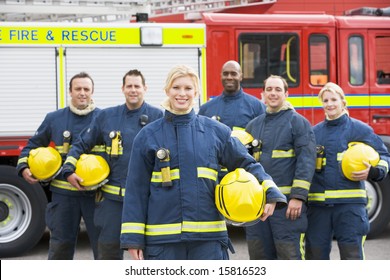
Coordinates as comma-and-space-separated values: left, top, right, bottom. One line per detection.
122, 75, 147, 110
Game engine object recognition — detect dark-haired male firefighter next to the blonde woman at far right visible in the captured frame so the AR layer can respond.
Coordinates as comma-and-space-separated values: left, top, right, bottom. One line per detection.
245, 75, 316, 260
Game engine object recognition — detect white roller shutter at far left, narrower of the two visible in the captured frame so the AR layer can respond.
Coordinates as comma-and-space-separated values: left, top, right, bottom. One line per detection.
0, 47, 57, 136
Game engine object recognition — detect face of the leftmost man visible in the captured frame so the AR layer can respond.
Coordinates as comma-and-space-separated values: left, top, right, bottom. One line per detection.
69, 78, 93, 110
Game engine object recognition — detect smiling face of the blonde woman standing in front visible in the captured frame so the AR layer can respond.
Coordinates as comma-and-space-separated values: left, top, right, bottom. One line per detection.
166, 75, 197, 113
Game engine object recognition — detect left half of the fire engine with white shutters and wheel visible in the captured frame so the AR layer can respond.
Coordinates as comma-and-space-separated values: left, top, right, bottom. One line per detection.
0, 22, 206, 257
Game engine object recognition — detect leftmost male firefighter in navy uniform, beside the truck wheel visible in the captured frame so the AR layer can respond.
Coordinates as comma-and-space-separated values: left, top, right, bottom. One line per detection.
17, 72, 99, 260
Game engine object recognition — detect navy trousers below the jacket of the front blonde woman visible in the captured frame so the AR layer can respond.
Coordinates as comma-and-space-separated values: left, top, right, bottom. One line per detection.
144, 240, 229, 260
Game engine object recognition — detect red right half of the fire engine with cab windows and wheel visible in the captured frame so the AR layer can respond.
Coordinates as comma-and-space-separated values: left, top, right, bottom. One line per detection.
203, 8, 390, 237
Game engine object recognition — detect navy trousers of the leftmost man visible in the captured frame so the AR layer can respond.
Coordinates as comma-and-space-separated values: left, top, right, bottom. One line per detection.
46, 192, 97, 260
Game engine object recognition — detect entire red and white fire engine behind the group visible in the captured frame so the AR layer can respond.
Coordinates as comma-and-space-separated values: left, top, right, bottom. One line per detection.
0, 1, 390, 257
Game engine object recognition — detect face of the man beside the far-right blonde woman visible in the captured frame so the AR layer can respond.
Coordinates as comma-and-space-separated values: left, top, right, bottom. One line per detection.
263, 77, 288, 112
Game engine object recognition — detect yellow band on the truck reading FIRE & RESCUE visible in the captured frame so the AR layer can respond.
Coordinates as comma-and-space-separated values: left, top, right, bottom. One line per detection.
0, 23, 206, 47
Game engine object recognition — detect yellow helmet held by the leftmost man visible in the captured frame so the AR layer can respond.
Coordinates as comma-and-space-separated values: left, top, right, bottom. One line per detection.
27, 147, 62, 181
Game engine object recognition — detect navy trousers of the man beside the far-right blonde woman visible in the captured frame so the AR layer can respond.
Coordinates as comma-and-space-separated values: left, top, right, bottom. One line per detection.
245, 205, 307, 260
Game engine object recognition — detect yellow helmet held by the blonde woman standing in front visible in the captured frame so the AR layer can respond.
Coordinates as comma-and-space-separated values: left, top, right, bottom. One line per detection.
215, 168, 266, 226
